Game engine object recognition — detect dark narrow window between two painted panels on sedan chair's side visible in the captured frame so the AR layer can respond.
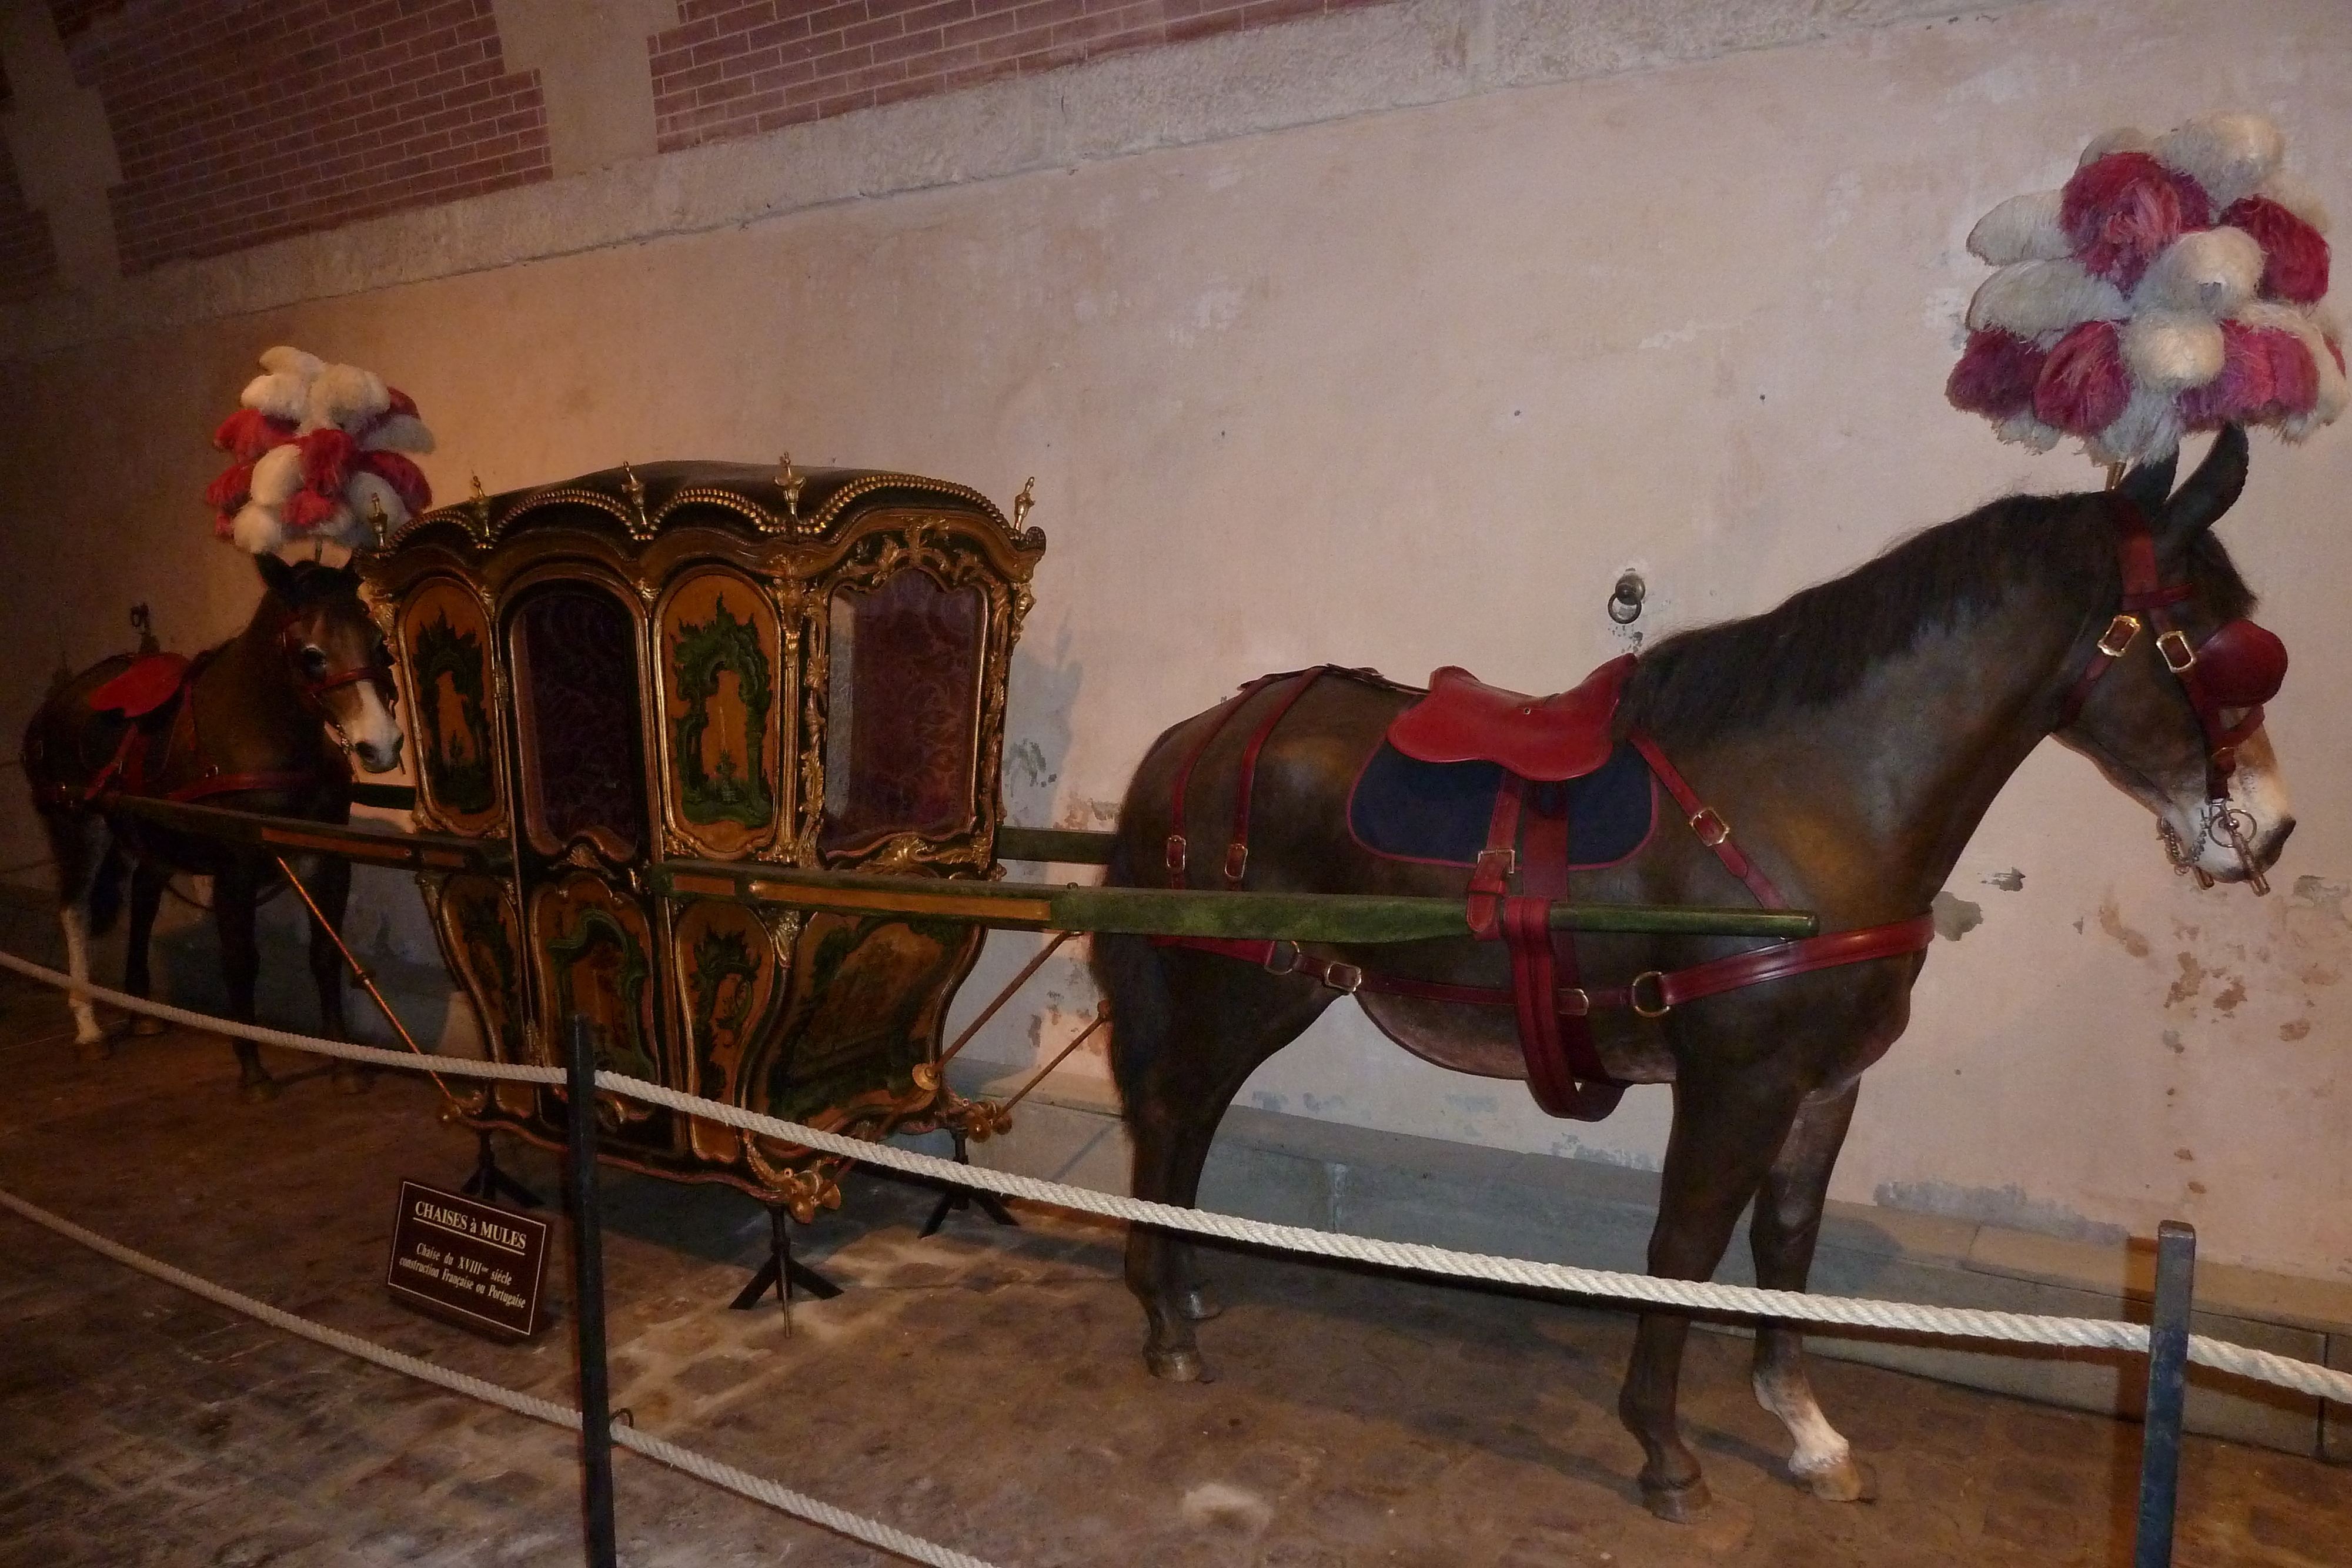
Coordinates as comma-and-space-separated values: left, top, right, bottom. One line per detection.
513, 586, 644, 860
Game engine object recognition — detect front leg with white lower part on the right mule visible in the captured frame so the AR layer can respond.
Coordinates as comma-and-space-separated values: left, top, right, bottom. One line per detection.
1748, 1084, 1877, 1502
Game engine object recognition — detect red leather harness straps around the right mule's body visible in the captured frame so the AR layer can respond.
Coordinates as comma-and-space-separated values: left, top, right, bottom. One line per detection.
1150, 656, 1936, 1121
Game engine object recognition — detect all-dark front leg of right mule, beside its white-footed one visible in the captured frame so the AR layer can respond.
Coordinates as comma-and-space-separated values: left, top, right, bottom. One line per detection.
1618, 1067, 1799, 1523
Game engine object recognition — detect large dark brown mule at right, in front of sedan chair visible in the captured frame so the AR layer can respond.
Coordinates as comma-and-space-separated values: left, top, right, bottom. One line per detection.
1096, 430, 2293, 1519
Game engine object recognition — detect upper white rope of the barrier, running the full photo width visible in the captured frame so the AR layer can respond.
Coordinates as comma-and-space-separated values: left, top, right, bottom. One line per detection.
0, 952, 2352, 1403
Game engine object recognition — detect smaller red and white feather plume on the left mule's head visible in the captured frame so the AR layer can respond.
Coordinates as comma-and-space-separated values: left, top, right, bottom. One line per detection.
205, 348, 433, 555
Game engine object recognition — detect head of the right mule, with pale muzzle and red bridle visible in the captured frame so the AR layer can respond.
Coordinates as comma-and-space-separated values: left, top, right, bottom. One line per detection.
2058, 426, 2296, 891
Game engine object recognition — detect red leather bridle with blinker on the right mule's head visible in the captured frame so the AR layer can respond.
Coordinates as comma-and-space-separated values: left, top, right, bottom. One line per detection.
2056, 492, 2286, 893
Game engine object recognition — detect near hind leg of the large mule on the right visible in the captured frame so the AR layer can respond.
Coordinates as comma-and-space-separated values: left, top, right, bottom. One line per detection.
1096, 938, 1334, 1382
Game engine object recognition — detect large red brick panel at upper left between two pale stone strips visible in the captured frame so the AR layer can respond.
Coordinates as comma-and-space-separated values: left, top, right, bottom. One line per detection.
54, 0, 550, 273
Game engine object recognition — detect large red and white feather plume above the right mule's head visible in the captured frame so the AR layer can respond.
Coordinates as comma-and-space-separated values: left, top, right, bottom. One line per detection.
1945, 115, 2352, 463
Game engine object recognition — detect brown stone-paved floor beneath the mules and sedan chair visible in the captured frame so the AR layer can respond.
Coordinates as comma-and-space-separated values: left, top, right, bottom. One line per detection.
0, 978, 2352, 1568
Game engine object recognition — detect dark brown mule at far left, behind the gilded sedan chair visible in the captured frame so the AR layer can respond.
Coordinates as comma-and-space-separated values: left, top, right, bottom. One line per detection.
24, 555, 400, 1100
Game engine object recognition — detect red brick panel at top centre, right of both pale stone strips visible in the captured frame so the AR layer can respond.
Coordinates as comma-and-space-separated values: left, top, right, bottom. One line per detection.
652, 0, 1378, 153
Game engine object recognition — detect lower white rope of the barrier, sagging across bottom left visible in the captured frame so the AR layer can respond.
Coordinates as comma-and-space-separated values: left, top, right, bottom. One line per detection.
0, 1189, 993, 1568
